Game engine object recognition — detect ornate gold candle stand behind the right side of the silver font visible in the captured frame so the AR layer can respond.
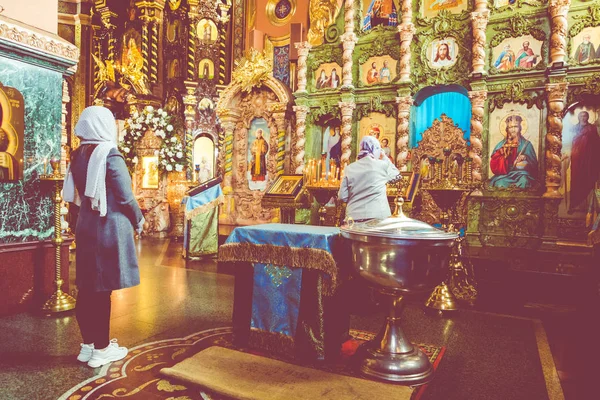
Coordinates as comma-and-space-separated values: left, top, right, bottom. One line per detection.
423, 149, 477, 311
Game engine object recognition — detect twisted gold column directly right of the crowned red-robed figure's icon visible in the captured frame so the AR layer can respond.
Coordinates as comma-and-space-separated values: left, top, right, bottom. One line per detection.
543, 82, 568, 198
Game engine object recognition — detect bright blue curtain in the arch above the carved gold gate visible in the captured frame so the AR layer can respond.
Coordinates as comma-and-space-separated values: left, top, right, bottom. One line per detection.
409, 88, 471, 147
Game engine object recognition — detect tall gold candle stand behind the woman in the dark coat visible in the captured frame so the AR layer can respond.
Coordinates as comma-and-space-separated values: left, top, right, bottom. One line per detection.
40, 159, 76, 313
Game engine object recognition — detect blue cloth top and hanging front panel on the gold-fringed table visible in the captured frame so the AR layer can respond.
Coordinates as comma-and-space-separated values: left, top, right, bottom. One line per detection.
226, 224, 340, 338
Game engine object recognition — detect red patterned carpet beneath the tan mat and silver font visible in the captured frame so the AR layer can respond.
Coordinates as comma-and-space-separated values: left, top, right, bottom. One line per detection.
59, 328, 445, 400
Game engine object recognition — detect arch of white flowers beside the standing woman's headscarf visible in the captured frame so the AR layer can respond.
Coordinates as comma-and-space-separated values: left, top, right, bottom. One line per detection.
119, 106, 185, 172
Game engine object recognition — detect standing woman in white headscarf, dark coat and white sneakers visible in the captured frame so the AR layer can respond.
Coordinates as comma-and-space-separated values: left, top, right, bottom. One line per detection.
64, 106, 144, 368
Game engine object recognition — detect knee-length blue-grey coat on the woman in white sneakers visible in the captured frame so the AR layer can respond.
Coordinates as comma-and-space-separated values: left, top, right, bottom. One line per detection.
71, 145, 142, 291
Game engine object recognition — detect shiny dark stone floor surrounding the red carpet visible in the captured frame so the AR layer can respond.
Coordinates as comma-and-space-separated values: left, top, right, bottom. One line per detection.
0, 238, 597, 400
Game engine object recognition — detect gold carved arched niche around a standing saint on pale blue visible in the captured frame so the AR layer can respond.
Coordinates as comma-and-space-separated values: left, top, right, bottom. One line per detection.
217, 76, 294, 225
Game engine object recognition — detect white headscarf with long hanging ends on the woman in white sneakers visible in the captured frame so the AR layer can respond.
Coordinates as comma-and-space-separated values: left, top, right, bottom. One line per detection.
63, 106, 117, 217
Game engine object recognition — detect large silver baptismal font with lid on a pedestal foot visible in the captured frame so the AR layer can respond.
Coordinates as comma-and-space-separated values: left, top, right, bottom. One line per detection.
341, 199, 458, 385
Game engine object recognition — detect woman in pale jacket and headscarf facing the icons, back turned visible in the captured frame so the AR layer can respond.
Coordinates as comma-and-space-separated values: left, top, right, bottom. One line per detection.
338, 136, 400, 221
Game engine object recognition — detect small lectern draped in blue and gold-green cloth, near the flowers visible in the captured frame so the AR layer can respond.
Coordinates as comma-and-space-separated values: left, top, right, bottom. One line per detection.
181, 185, 223, 258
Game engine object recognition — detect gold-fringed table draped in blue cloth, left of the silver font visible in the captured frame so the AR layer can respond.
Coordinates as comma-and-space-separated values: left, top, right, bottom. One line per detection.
219, 224, 349, 360
